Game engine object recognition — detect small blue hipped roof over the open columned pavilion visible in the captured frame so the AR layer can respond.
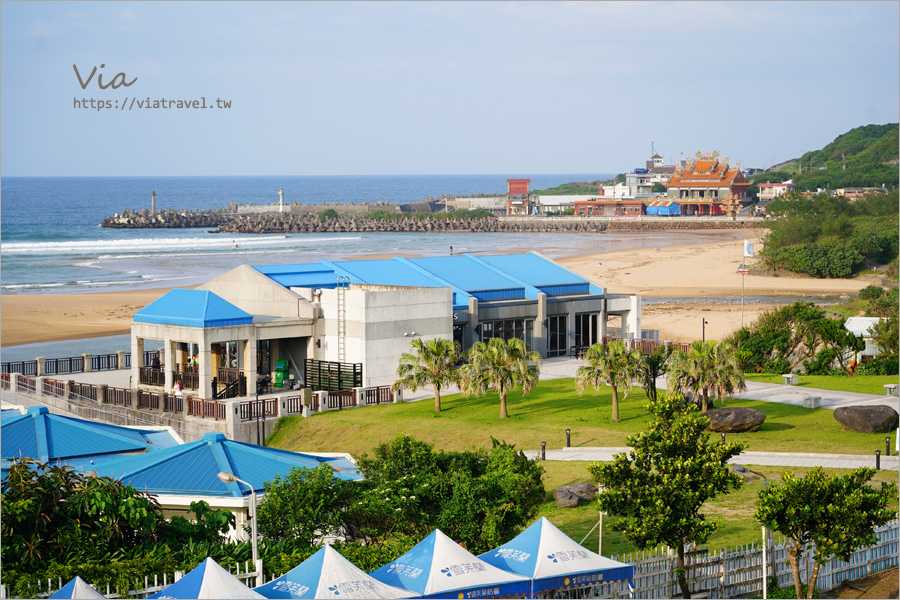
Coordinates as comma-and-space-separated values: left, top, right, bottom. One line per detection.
134, 289, 253, 327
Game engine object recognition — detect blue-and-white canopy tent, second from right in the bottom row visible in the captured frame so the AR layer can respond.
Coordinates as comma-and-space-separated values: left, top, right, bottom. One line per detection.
370, 529, 531, 598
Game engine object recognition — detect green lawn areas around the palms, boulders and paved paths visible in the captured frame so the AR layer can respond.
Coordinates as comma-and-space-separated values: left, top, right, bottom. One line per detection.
267, 375, 897, 556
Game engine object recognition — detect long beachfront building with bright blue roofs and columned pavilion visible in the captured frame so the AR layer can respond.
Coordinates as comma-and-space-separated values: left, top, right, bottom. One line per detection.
131, 252, 641, 398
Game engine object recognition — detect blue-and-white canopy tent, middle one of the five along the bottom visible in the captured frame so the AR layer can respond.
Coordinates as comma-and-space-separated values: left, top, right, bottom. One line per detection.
254, 545, 418, 598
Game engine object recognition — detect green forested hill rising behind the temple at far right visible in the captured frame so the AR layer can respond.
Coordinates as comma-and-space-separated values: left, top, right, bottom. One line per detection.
750, 123, 900, 194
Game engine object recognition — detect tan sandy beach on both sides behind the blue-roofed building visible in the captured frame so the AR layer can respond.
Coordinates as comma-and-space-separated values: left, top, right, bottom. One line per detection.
0, 230, 869, 347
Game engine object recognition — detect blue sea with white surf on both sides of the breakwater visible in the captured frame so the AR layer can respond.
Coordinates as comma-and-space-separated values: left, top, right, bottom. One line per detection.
0, 174, 624, 294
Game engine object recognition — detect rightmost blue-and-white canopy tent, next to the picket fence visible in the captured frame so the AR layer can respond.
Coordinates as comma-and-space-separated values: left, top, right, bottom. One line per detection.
479, 517, 634, 593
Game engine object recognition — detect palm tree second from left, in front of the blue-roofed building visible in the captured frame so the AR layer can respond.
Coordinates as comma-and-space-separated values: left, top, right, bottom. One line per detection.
463, 338, 541, 419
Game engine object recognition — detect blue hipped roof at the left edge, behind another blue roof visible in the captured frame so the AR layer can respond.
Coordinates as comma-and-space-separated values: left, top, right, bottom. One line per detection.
0, 406, 174, 462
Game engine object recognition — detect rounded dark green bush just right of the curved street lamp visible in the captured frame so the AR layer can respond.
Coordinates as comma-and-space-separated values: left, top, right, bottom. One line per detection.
257, 465, 354, 547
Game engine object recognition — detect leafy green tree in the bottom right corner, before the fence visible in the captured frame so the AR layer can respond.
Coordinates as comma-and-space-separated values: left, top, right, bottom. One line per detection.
755, 467, 897, 598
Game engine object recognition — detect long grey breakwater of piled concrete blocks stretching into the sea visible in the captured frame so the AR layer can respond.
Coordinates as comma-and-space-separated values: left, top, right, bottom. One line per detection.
100, 207, 756, 233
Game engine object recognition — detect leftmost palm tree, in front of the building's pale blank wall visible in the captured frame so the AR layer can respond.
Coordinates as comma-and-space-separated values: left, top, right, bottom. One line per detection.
392, 338, 459, 412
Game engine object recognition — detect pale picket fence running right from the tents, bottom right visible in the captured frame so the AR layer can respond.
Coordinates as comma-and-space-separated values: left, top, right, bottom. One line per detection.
612, 521, 900, 598
